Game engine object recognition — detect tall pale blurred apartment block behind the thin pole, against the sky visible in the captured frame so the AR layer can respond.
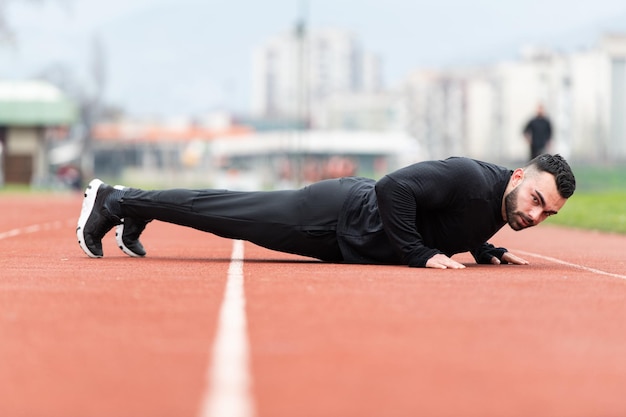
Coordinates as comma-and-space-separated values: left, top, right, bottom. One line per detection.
252, 28, 381, 127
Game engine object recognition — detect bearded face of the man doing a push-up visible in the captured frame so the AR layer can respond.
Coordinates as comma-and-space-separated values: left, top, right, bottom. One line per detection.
504, 172, 567, 230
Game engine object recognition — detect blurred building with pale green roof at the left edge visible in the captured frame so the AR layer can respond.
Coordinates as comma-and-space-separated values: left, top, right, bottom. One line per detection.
0, 81, 78, 185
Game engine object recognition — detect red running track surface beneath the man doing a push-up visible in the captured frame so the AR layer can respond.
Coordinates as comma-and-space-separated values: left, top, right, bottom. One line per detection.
0, 195, 626, 417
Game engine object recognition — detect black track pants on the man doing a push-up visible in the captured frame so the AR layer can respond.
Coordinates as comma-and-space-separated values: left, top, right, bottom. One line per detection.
120, 178, 355, 262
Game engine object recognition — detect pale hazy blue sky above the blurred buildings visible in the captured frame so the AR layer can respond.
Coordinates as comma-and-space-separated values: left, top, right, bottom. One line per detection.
0, 0, 626, 117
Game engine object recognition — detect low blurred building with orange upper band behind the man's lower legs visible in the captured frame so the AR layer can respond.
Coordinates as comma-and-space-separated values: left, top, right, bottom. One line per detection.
91, 113, 251, 186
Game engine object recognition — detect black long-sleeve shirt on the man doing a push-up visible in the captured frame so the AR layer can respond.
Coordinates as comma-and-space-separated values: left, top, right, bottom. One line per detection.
337, 157, 512, 267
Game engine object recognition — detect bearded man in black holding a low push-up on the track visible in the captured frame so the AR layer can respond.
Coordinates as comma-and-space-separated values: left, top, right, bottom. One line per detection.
76, 154, 576, 269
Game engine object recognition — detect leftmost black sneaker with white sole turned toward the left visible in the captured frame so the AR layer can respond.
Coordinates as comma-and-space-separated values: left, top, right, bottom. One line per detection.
76, 179, 121, 258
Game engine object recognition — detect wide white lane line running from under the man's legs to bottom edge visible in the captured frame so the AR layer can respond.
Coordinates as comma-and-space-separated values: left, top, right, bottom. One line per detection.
200, 240, 254, 417
